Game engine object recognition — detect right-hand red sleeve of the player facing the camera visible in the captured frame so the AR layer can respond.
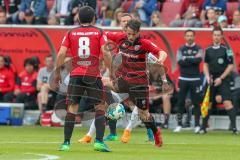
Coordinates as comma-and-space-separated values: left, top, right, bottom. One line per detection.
142, 40, 162, 57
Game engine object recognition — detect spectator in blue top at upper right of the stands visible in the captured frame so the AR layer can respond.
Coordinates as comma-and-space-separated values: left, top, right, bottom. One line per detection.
200, 0, 227, 23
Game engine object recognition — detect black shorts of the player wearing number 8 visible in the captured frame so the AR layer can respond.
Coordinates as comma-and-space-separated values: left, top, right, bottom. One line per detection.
67, 76, 103, 106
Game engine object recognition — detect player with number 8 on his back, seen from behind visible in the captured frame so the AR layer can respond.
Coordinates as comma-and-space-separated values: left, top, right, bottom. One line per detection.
55, 6, 110, 152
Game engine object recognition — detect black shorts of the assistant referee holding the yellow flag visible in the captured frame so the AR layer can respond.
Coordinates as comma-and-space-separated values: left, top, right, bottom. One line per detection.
210, 76, 232, 102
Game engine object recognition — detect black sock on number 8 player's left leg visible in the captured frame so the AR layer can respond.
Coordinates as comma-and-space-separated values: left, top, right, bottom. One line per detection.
64, 112, 76, 143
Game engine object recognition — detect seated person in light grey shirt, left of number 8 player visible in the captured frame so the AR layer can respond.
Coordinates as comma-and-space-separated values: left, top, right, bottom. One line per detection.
37, 55, 54, 113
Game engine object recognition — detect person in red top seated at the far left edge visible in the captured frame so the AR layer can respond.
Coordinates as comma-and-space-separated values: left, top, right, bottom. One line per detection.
0, 55, 15, 101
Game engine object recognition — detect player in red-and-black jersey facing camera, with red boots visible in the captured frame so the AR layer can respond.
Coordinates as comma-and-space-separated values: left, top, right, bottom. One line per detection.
106, 20, 167, 147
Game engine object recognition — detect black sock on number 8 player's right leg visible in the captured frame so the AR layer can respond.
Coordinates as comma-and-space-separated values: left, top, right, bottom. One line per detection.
95, 110, 106, 142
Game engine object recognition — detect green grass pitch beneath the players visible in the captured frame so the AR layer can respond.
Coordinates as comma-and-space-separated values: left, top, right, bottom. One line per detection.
0, 126, 240, 160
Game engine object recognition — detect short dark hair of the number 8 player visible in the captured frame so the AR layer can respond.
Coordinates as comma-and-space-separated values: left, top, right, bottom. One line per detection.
78, 6, 95, 24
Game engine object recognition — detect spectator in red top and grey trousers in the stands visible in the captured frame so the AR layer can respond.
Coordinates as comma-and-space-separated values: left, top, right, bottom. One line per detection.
170, 0, 203, 27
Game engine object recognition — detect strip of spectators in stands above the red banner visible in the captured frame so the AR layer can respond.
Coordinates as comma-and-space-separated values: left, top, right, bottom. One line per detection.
0, 0, 240, 28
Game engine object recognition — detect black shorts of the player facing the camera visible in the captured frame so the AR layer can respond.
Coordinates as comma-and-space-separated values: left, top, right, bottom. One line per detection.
117, 78, 149, 110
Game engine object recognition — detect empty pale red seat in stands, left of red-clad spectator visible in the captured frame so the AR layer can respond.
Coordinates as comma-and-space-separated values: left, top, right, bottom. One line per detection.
162, 1, 183, 25
